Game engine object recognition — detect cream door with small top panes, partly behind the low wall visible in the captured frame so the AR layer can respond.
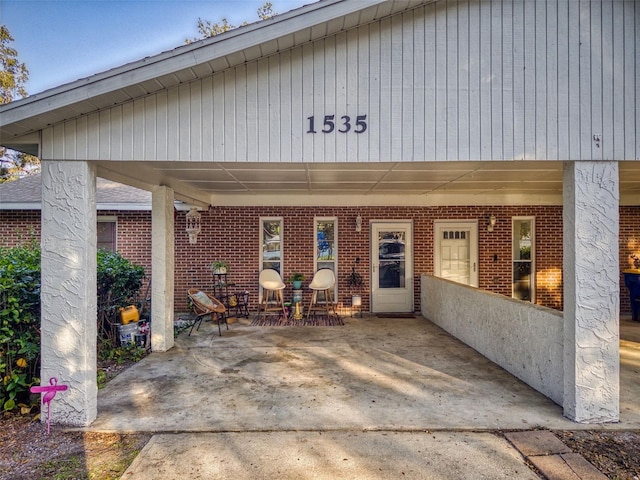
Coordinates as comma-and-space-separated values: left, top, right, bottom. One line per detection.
434, 221, 478, 287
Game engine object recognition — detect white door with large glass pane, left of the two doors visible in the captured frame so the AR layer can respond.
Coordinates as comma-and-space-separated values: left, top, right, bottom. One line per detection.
371, 221, 413, 313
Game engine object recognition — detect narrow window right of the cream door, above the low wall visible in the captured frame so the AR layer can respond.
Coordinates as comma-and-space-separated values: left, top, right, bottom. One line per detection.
511, 217, 536, 302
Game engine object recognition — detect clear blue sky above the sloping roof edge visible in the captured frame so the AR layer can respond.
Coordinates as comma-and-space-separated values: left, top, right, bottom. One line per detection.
0, 0, 316, 95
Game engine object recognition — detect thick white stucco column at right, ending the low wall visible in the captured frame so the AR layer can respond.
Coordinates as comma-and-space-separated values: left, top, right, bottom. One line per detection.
563, 161, 620, 423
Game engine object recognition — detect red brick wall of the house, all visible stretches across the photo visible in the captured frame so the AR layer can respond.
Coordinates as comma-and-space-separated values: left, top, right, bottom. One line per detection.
0, 206, 640, 314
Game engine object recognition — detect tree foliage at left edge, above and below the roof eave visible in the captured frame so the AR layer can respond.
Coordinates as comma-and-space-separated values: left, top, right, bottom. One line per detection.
0, 25, 40, 183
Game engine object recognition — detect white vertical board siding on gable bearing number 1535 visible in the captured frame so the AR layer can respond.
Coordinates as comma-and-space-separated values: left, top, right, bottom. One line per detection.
43, 0, 640, 162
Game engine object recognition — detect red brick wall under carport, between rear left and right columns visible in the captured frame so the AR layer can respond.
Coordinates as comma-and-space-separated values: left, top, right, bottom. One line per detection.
175, 206, 562, 310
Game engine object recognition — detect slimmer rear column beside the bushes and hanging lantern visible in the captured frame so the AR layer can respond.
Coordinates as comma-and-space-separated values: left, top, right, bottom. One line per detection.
151, 187, 175, 352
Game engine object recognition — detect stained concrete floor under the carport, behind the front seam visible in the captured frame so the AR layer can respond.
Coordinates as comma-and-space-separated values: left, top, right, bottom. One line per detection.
91, 316, 640, 432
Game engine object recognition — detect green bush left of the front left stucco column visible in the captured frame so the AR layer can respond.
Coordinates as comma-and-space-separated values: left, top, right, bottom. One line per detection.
0, 241, 40, 411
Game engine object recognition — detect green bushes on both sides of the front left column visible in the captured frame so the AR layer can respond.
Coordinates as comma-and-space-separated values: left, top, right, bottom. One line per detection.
0, 244, 146, 411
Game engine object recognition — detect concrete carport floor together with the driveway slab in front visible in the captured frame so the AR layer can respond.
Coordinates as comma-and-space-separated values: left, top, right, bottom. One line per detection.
91, 317, 640, 480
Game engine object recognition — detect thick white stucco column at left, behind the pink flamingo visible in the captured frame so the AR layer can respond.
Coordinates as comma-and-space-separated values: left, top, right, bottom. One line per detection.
40, 161, 98, 426
